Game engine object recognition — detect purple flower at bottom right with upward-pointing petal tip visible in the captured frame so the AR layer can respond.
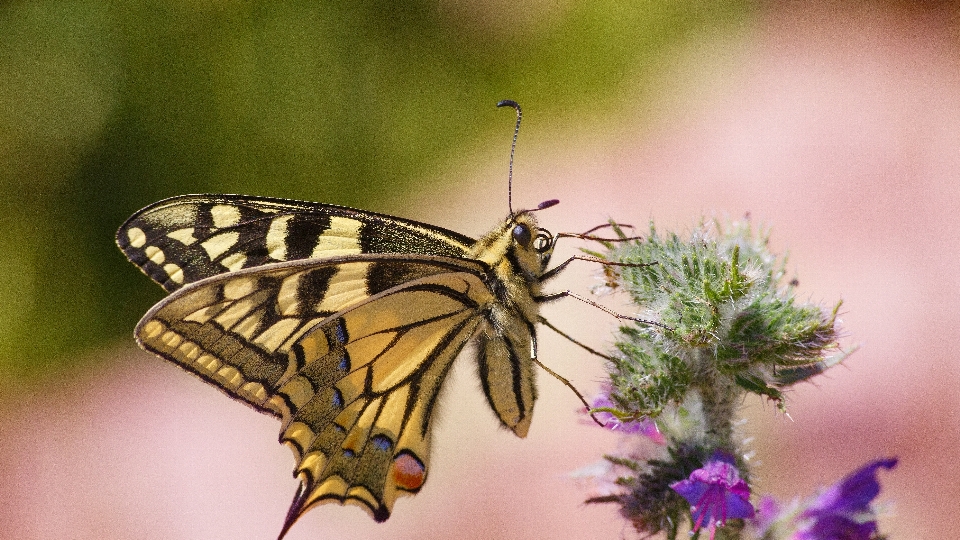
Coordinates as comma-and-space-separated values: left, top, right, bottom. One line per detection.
795, 458, 897, 540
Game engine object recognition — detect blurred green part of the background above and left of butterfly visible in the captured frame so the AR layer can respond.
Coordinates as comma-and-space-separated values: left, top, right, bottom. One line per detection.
0, 0, 750, 381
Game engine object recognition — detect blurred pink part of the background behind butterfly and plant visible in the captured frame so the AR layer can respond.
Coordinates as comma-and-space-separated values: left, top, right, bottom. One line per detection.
0, 4, 960, 540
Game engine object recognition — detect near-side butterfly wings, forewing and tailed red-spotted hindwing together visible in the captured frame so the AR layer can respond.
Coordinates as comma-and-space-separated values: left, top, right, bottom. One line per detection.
136, 255, 496, 536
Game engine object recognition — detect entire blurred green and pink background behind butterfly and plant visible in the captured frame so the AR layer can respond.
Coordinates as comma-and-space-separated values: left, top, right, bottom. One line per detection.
0, 0, 960, 540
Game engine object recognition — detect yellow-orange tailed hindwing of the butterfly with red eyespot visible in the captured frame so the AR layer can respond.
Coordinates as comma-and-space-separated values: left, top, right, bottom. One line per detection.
279, 272, 490, 524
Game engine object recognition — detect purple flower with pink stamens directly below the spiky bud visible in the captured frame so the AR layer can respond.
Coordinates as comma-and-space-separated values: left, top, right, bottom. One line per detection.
670, 452, 754, 540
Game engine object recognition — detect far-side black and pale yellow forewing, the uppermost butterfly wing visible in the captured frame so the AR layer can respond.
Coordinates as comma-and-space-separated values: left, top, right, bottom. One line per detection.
117, 195, 474, 292
